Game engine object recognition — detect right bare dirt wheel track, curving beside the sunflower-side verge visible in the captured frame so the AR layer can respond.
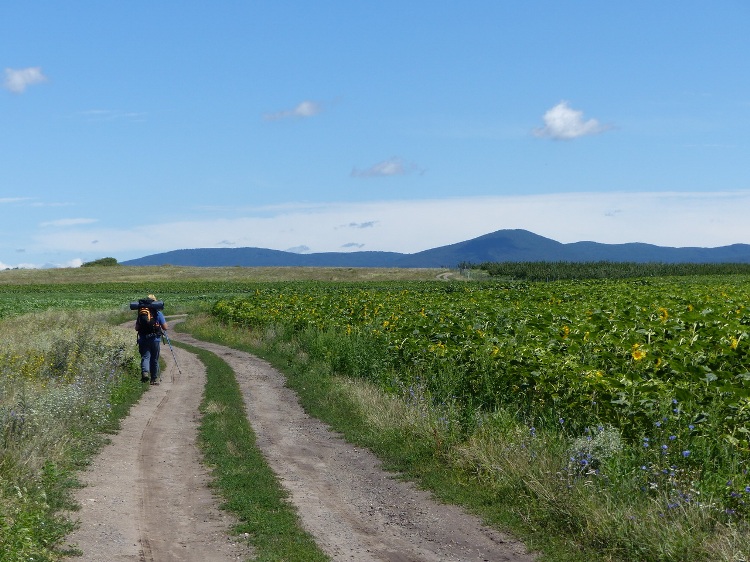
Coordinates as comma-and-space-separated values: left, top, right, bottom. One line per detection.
172, 333, 534, 562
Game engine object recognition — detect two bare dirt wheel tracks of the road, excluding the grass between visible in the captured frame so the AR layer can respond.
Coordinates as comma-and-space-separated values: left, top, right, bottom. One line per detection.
68, 326, 533, 562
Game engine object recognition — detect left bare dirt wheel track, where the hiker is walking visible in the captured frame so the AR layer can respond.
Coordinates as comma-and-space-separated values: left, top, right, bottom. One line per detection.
67, 328, 250, 562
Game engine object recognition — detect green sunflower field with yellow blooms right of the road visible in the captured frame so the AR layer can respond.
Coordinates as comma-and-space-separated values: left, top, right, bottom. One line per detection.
213, 277, 750, 442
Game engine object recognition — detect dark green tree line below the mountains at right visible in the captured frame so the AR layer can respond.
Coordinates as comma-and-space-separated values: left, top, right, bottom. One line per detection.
459, 261, 750, 281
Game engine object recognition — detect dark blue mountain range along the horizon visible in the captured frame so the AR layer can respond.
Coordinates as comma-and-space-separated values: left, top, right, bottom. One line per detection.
121, 229, 750, 268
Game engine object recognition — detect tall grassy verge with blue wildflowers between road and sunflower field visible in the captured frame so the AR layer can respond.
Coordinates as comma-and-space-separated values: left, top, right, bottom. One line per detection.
184, 310, 750, 561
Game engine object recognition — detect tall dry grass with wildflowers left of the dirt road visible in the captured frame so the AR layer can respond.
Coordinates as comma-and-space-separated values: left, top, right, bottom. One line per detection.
0, 311, 141, 561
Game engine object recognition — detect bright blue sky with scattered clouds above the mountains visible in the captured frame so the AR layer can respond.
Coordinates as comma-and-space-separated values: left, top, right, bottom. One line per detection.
0, 0, 750, 268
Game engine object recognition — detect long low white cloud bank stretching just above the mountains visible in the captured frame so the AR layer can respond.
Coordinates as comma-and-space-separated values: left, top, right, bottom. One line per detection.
26, 191, 750, 261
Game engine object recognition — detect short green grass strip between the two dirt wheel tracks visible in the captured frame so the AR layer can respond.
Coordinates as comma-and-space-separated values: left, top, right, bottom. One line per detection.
176, 336, 328, 562
